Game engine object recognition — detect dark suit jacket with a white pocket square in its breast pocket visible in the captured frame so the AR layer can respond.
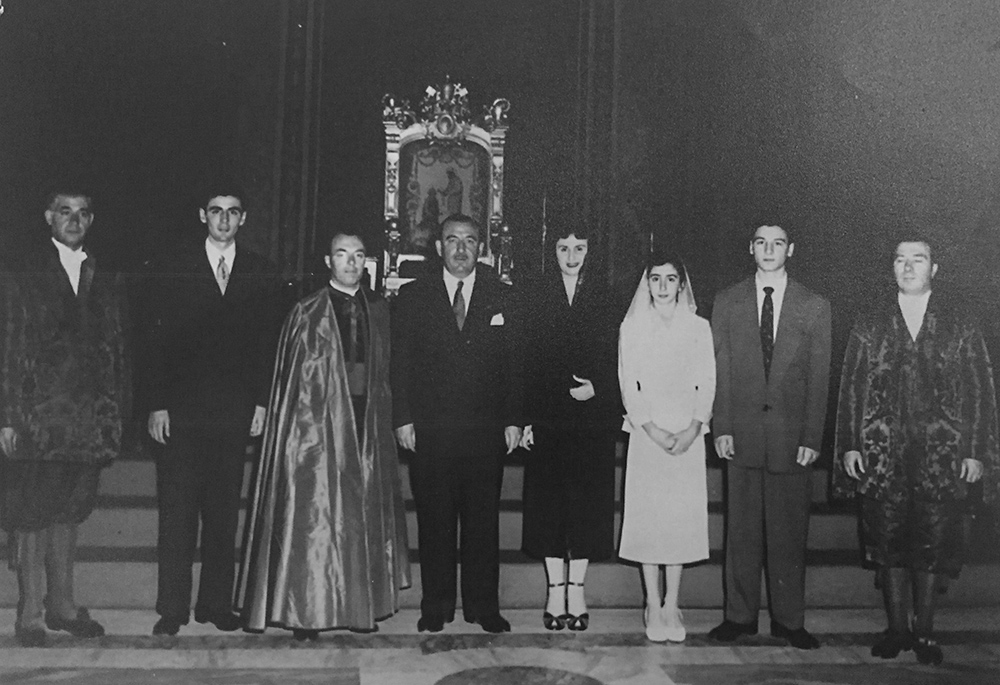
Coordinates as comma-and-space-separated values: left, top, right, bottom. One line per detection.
391, 264, 524, 432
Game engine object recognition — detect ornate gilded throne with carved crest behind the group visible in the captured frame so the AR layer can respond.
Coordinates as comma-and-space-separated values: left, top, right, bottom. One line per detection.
380, 77, 512, 295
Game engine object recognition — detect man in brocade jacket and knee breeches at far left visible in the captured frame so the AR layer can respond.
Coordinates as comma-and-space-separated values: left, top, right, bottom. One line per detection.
0, 187, 131, 647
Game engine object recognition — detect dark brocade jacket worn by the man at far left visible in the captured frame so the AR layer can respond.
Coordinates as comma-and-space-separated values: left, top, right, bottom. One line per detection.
0, 240, 131, 464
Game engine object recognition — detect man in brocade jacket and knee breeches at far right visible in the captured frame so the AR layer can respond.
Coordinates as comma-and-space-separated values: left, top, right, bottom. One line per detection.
833, 236, 1000, 664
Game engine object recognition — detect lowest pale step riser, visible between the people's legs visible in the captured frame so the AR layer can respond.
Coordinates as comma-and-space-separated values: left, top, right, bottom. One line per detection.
0, 550, 1000, 608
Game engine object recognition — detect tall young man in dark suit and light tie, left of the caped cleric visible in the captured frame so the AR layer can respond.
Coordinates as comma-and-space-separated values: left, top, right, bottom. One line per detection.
146, 185, 278, 635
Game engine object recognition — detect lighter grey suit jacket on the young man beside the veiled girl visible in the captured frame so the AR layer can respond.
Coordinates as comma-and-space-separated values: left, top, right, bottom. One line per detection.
712, 278, 830, 473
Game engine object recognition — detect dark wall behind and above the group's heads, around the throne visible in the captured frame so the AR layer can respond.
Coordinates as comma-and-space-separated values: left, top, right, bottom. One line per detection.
0, 0, 1000, 454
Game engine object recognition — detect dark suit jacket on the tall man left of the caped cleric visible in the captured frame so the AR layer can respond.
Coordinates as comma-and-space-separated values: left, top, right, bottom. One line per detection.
143, 242, 281, 428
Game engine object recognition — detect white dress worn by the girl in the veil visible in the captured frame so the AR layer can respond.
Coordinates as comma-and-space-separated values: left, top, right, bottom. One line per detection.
618, 306, 715, 564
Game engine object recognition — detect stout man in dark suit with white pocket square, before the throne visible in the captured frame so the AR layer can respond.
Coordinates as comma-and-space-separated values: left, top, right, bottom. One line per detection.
390, 214, 523, 633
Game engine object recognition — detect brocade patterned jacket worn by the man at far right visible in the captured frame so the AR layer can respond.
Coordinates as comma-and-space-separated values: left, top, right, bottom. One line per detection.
833, 292, 1000, 502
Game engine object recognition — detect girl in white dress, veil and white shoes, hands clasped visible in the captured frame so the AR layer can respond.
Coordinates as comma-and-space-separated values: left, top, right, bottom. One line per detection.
618, 253, 715, 642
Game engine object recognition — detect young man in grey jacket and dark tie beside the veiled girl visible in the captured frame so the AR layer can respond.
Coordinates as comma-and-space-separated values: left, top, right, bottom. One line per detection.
709, 225, 830, 649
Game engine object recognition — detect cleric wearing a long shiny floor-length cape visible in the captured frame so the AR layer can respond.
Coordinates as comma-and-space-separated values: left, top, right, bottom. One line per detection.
236, 233, 410, 640
